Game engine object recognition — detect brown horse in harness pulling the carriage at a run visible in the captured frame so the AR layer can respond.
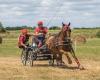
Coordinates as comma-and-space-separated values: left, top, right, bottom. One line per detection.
46, 23, 83, 69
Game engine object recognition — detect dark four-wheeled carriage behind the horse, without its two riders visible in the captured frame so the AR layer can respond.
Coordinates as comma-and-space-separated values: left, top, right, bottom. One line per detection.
21, 38, 54, 67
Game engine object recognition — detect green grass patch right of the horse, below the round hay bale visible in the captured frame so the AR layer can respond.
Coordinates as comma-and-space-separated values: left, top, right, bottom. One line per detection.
76, 38, 100, 60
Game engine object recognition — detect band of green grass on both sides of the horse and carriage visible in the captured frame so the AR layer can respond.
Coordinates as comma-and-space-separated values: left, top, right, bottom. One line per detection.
0, 38, 100, 60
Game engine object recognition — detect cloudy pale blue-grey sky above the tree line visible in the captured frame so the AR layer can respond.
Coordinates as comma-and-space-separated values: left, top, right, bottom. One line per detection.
0, 0, 100, 27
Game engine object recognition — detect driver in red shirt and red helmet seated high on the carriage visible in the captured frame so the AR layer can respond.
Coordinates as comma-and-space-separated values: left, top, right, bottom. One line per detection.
34, 21, 48, 48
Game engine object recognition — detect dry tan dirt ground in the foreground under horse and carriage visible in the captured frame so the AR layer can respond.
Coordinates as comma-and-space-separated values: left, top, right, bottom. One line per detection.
0, 57, 100, 80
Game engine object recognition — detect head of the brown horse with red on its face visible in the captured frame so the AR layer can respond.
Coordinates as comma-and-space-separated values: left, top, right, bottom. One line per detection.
62, 22, 71, 37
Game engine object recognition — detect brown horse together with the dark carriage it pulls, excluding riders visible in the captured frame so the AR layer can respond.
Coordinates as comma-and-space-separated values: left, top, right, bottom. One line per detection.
21, 23, 84, 69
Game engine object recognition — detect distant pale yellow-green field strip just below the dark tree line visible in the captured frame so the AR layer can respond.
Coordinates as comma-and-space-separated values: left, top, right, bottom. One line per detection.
0, 29, 100, 38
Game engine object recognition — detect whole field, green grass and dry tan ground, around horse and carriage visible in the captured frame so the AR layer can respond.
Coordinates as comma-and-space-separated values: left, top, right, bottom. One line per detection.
0, 29, 100, 80
